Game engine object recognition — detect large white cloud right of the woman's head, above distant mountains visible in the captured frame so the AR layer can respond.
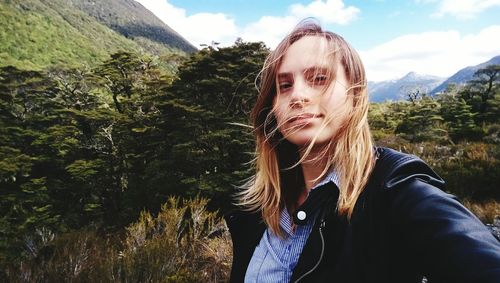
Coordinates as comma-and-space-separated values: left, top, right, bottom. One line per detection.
360, 25, 500, 81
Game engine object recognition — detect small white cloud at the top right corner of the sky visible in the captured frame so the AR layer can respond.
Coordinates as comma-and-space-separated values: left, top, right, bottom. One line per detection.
416, 0, 500, 19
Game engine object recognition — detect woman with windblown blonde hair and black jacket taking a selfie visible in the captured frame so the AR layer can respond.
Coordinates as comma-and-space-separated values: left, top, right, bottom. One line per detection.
226, 22, 500, 283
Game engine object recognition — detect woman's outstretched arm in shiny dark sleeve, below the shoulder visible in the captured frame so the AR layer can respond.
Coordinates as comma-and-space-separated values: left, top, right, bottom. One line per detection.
392, 178, 500, 283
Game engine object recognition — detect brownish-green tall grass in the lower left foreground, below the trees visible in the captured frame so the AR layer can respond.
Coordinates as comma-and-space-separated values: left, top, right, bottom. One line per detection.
5, 198, 232, 282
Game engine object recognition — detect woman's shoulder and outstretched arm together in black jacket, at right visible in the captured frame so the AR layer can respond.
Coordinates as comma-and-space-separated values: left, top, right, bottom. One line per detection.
369, 148, 500, 282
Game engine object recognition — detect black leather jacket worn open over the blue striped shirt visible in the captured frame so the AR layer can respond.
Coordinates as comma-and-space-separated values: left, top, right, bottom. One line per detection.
226, 148, 500, 283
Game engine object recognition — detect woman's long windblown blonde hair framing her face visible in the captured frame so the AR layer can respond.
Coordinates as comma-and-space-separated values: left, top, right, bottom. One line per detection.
238, 21, 375, 236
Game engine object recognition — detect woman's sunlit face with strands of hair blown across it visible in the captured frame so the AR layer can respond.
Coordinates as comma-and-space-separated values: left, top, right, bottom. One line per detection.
273, 36, 352, 147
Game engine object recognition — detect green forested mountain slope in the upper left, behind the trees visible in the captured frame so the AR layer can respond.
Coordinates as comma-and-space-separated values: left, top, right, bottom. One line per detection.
0, 0, 195, 69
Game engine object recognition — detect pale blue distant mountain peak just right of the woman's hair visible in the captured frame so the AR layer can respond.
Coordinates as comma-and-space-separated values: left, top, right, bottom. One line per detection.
368, 72, 445, 102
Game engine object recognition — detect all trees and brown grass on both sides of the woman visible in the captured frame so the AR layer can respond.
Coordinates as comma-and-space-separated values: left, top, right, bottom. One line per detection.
0, 37, 500, 282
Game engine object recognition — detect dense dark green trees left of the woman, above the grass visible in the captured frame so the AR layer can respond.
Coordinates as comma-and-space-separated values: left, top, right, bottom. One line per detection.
0, 41, 267, 272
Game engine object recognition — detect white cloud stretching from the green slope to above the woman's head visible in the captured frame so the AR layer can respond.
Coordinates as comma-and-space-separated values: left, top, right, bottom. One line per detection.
136, 0, 360, 48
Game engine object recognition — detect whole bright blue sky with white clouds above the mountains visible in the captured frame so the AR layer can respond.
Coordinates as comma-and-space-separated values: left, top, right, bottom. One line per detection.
136, 0, 500, 81
